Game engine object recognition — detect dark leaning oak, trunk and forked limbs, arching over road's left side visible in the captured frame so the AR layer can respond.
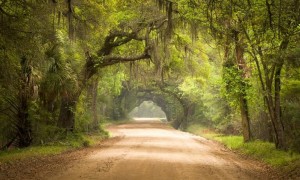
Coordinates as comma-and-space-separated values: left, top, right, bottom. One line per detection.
58, 5, 172, 130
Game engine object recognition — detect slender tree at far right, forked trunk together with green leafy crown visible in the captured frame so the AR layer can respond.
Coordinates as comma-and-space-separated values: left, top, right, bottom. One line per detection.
234, 0, 300, 149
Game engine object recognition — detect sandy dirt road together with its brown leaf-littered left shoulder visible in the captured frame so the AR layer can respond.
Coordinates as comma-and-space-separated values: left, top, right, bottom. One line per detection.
0, 120, 292, 180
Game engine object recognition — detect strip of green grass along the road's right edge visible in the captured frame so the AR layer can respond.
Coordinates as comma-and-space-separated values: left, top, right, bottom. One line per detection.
187, 124, 300, 168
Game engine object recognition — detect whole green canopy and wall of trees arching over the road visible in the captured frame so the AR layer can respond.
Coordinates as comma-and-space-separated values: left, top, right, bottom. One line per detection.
0, 0, 300, 151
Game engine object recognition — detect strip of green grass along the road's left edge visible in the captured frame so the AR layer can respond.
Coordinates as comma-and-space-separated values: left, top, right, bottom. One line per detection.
0, 131, 109, 164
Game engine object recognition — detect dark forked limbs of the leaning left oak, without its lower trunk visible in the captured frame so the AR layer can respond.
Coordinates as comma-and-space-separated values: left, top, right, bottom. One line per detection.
82, 17, 168, 81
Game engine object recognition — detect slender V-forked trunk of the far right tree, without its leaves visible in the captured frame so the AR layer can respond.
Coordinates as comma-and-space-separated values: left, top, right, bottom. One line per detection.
243, 15, 290, 149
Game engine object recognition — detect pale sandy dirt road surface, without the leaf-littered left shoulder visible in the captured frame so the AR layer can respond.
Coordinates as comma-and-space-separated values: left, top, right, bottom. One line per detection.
50, 120, 269, 180
